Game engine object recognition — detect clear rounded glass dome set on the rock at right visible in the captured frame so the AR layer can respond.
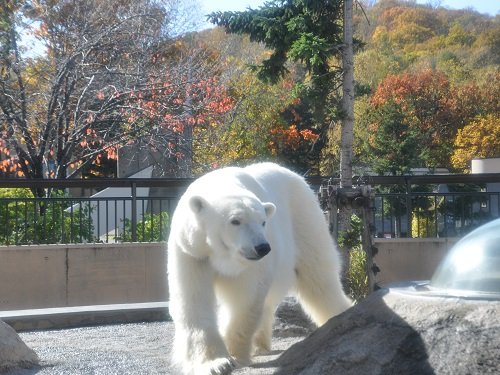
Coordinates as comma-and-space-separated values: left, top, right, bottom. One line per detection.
428, 219, 500, 298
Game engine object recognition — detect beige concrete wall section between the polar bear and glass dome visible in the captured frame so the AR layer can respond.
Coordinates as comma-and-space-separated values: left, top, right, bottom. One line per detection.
374, 238, 458, 286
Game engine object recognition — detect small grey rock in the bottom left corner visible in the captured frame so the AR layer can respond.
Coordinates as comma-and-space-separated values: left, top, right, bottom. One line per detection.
0, 320, 38, 373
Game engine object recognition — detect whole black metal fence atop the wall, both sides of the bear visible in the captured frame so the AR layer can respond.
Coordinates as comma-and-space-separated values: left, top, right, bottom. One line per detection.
0, 174, 500, 245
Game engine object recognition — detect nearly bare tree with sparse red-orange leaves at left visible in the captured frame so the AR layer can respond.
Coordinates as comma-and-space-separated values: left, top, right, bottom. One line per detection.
0, 0, 227, 188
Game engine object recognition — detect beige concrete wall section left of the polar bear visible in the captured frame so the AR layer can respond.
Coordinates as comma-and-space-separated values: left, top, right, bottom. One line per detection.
0, 243, 168, 310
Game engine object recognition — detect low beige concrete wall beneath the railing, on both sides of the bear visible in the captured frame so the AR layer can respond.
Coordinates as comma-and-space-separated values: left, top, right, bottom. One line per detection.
0, 239, 456, 310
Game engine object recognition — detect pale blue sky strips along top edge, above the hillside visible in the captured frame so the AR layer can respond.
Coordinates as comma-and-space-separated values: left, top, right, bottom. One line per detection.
199, 0, 500, 16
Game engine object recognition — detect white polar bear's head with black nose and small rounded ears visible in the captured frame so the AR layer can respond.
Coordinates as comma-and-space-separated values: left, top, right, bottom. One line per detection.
189, 194, 276, 274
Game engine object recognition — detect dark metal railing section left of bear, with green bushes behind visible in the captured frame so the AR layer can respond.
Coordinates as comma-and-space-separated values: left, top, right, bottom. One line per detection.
0, 179, 191, 245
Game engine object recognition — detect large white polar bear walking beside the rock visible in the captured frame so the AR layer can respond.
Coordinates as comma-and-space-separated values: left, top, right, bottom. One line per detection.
168, 163, 352, 375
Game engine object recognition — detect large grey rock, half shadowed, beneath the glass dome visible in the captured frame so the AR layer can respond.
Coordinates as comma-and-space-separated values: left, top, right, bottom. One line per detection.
270, 290, 500, 375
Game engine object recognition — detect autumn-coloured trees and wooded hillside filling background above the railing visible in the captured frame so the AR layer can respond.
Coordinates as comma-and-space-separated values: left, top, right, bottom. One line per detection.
0, 0, 500, 182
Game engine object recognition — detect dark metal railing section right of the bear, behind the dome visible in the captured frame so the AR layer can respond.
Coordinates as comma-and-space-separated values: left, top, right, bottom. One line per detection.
364, 173, 500, 238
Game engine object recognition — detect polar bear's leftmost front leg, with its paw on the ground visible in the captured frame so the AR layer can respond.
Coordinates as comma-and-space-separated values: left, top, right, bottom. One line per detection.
168, 248, 235, 375
